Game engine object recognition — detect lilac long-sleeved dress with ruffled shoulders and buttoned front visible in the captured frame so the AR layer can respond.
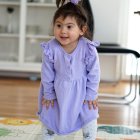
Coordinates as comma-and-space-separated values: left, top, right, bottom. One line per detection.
38, 37, 100, 135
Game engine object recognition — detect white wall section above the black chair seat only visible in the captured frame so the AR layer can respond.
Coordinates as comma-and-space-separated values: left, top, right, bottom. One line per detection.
89, 0, 129, 45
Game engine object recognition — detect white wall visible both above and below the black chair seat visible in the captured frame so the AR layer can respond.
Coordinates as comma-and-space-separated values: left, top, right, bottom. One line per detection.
89, 0, 129, 82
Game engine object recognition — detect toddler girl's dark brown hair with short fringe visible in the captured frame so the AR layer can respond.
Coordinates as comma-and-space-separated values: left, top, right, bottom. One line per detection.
53, 2, 92, 40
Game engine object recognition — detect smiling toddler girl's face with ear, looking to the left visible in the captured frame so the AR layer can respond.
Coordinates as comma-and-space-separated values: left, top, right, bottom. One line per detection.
54, 16, 84, 47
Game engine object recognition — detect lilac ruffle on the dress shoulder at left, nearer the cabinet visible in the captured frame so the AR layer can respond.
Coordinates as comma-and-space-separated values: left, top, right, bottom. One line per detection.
40, 42, 54, 63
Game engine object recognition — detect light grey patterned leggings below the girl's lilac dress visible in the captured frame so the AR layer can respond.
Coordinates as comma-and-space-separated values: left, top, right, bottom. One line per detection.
42, 120, 97, 140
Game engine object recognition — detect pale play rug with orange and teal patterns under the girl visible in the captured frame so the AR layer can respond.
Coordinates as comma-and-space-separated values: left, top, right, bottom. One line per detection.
0, 118, 140, 140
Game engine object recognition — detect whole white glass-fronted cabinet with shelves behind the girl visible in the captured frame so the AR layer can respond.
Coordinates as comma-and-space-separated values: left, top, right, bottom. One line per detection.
0, 0, 56, 72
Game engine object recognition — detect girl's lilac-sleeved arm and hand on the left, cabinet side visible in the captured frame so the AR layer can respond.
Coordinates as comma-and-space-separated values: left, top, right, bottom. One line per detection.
41, 43, 56, 107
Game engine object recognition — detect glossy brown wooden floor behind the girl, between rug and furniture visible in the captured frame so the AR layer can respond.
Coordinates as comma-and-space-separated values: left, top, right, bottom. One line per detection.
0, 78, 140, 126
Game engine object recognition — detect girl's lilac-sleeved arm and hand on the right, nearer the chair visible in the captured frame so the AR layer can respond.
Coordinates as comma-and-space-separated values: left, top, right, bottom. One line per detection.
84, 43, 100, 109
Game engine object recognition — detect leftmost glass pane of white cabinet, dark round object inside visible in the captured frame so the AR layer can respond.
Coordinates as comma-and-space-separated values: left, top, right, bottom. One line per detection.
0, 1, 20, 63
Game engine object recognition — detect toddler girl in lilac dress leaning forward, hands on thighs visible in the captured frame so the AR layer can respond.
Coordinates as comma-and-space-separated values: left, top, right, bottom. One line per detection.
39, 1, 100, 140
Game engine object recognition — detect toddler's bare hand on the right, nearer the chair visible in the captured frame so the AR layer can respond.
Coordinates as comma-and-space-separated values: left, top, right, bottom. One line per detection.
84, 98, 98, 110
